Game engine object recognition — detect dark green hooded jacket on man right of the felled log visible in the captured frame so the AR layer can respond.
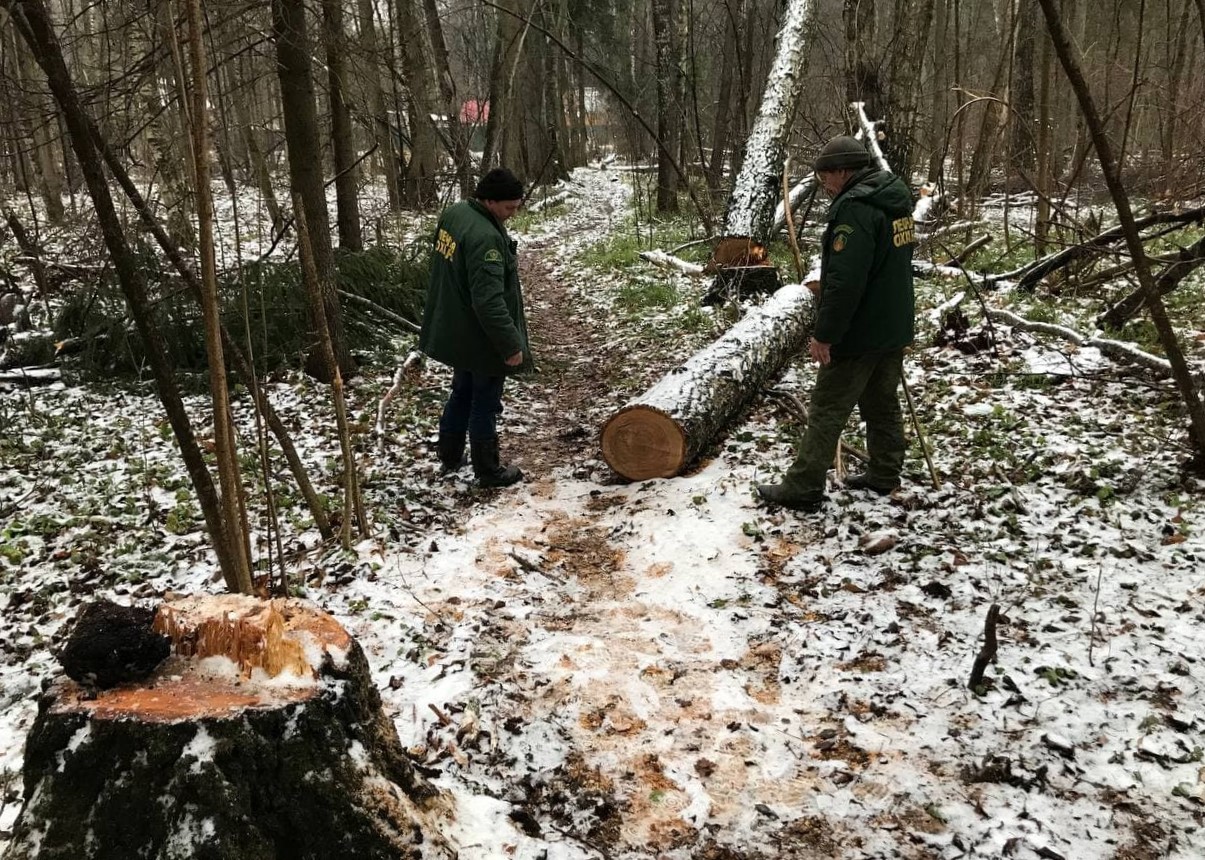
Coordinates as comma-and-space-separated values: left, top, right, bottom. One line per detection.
812, 167, 916, 358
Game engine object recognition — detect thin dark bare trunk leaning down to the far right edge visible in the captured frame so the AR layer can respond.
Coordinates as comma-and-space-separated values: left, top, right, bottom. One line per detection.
1039, 0, 1205, 462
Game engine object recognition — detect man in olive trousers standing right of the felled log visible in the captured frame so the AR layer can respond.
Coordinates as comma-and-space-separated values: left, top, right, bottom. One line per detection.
757, 137, 916, 511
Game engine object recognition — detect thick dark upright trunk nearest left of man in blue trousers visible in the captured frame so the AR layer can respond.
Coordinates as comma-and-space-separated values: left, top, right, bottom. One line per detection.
272, 0, 355, 382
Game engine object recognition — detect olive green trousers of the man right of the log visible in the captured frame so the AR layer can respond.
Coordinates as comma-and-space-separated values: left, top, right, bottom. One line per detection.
782, 349, 907, 497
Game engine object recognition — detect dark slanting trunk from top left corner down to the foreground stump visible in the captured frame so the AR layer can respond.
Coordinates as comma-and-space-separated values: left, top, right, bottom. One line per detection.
0, 0, 247, 591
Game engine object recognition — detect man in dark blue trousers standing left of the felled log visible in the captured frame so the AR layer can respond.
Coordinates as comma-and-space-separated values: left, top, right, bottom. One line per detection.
418, 167, 531, 487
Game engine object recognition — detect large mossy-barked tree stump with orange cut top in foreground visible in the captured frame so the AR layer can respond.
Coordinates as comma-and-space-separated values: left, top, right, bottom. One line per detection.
5, 595, 455, 860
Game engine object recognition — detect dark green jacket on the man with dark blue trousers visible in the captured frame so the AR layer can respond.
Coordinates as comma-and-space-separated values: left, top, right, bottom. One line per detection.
418, 200, 531, 376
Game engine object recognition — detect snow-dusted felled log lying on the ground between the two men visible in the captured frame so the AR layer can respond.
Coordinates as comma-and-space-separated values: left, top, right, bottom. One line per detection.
603, 284, 812, 481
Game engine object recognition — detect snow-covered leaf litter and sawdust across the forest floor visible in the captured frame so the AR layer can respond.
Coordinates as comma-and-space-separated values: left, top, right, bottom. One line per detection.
0, 171, 1205, 858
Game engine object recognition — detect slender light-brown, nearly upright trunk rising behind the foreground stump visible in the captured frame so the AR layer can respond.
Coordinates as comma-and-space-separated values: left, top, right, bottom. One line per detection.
180, 0, 251, 594
